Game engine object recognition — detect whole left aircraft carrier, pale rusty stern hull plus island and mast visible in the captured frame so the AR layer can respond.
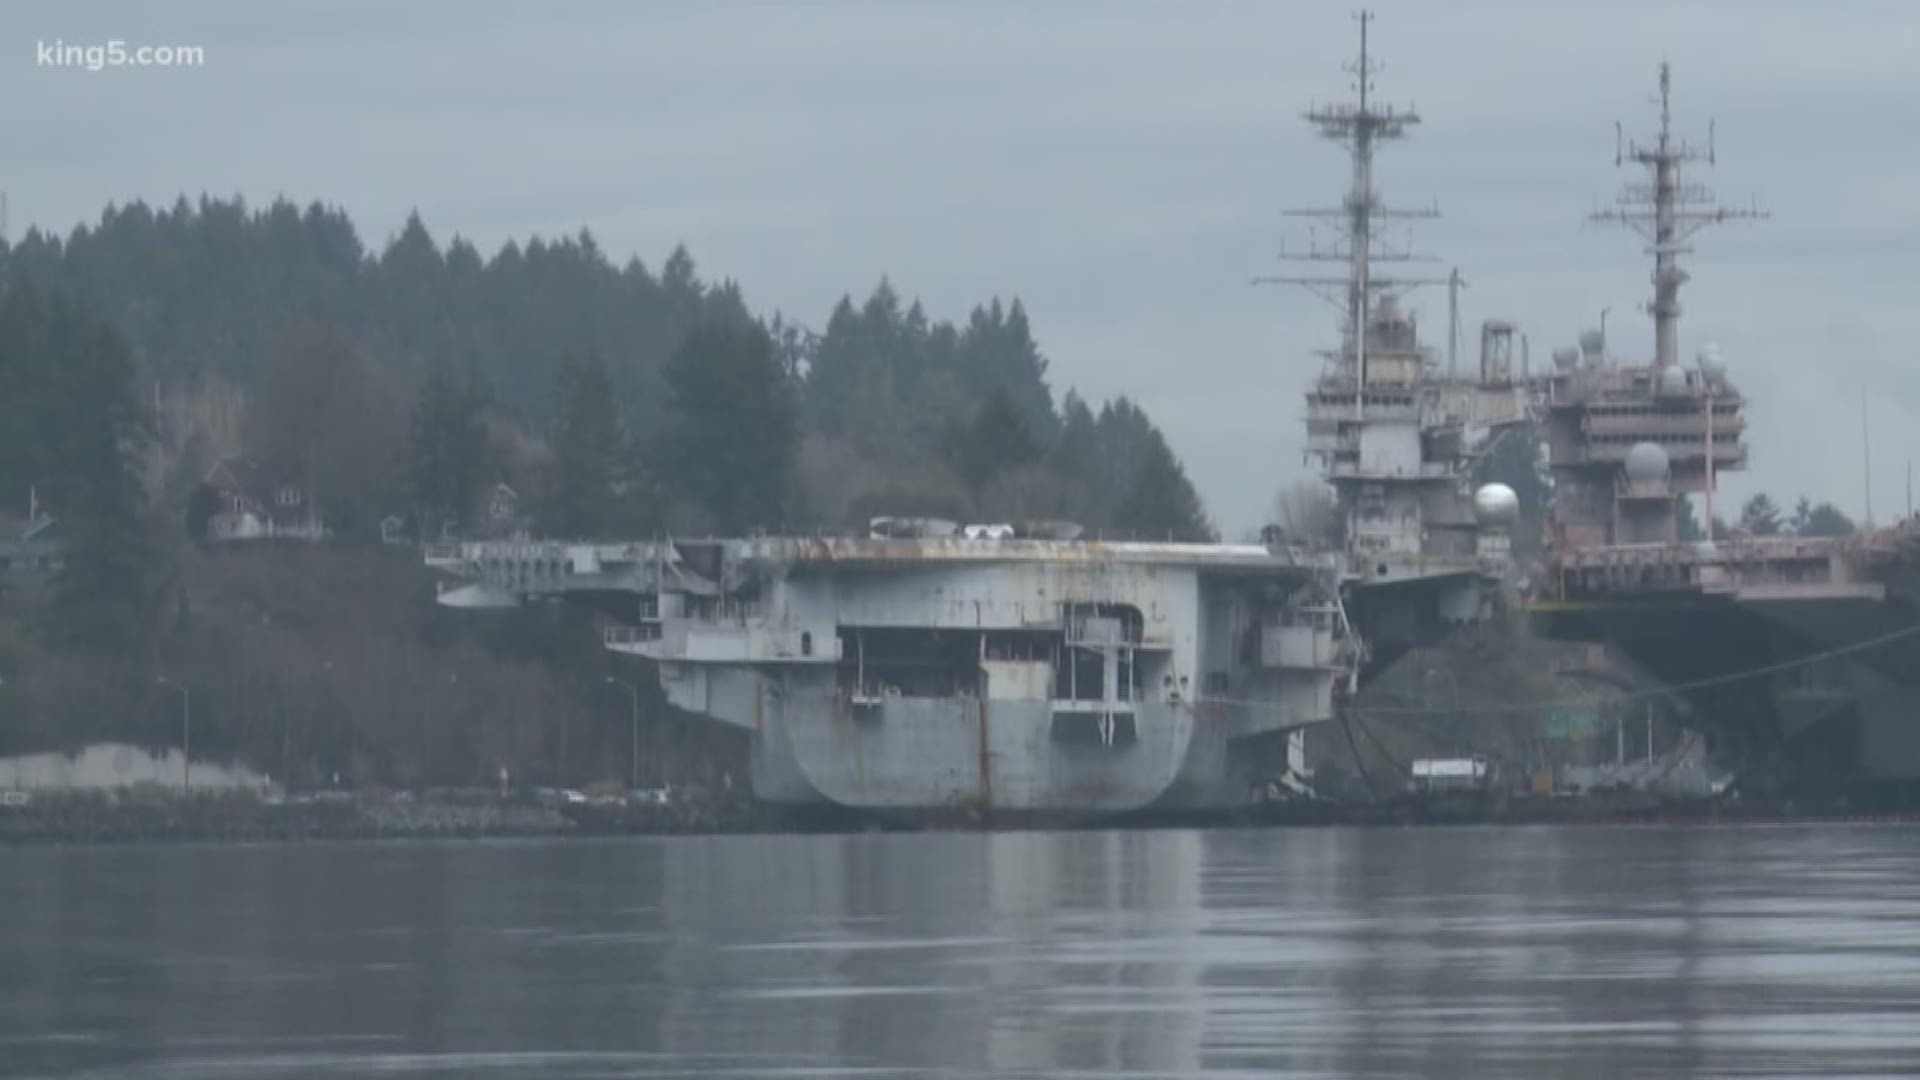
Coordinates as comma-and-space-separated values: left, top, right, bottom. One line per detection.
426, 21, 1524, 819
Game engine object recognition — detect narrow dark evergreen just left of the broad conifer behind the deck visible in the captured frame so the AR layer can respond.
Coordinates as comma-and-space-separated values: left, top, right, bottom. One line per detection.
543, 357, 626, 538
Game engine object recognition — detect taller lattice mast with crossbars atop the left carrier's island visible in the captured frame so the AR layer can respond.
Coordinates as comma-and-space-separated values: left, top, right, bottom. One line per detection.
1254, 12, 1446, 407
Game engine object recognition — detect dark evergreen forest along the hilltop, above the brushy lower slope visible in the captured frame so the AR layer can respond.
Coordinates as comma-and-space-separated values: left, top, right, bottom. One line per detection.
0, 200, 1212, 538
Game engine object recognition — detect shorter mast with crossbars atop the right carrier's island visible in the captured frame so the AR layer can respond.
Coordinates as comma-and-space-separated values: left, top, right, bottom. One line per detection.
1588, 63, 1768, 368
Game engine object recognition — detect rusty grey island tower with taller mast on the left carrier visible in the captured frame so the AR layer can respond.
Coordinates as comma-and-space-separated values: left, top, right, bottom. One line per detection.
1254, 12, 1528, 667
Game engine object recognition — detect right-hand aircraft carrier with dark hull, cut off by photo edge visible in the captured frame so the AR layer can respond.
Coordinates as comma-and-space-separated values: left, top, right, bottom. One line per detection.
1528, 63, 1920, 799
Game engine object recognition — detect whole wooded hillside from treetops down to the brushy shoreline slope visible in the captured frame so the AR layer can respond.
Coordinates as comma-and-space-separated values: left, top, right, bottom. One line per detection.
0, 200, 1212, 786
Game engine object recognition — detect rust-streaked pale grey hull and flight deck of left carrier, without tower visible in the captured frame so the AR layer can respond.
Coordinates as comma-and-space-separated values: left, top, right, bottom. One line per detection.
426, 519, 1354, 819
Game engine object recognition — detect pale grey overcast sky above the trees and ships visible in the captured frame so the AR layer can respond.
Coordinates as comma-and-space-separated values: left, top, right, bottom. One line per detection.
0, 0, 1920, 534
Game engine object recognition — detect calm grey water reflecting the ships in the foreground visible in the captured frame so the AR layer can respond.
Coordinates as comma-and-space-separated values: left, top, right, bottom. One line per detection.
0, 826, 1920, 1080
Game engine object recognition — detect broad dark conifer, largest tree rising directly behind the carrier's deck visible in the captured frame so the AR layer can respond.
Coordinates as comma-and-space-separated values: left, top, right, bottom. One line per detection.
659, 319, 797, 534
